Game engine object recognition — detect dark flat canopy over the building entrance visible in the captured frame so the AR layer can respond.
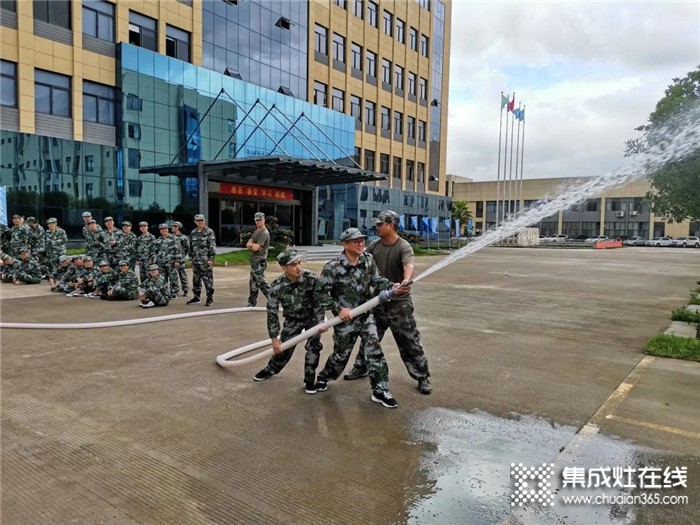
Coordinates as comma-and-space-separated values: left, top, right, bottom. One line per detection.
139, 156, 386, 190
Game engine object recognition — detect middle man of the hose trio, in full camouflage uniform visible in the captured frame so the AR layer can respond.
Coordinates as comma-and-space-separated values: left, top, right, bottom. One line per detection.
316, 228, 408, 408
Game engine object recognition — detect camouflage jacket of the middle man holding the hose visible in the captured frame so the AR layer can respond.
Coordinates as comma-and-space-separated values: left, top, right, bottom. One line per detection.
316, 253, 393, 315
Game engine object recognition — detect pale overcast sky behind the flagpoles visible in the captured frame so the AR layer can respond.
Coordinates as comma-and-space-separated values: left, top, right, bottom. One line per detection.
447, 0, 700, 181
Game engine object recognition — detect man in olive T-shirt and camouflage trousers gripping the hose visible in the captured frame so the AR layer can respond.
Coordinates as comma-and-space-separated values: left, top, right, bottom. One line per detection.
344, 210, 431, 394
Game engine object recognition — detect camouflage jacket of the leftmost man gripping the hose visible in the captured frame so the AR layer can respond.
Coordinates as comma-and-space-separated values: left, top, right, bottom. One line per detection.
267, 270, 323, 339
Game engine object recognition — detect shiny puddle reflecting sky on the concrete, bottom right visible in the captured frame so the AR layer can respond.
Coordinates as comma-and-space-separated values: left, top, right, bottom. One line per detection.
408, 408, 699, 525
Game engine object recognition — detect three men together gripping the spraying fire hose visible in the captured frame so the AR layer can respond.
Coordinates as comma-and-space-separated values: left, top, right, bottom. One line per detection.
251, 210, 432, 408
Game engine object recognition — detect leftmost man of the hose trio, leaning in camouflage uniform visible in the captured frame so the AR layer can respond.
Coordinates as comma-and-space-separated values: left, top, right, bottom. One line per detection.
253, 250, 325, 394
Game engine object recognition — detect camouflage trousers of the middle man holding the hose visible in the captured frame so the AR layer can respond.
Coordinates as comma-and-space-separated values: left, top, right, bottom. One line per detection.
318, 312, 389, 392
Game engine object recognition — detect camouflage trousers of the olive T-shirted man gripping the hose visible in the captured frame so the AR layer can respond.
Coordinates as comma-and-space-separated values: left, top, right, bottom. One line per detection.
354, 299, 430, 380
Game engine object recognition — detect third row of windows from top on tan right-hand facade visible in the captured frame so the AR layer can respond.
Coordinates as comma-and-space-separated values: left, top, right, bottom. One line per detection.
314, 81, 427, 142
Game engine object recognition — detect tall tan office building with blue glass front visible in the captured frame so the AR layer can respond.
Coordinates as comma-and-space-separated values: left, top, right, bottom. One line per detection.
0, 0, 450, 244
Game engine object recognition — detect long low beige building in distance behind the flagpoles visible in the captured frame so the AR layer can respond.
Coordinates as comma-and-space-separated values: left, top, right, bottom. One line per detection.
449, 178, 700, 239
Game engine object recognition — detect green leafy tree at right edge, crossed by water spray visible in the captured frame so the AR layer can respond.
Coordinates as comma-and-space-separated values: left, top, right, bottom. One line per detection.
625, 66, 700, 222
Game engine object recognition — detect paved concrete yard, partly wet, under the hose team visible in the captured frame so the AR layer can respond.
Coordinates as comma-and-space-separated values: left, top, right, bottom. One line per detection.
0, 248, 700, 525
